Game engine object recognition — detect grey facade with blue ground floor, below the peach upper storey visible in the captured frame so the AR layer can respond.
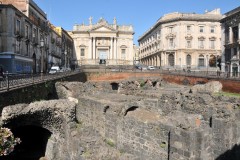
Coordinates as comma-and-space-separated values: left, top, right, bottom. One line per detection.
0, 5, 47, 73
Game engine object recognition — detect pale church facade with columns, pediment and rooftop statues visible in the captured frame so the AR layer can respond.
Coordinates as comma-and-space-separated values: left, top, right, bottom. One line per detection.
70, 17, 134, 65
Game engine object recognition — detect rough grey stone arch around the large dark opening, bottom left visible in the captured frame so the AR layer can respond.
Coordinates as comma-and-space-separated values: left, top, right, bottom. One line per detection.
2, 99, 76, 159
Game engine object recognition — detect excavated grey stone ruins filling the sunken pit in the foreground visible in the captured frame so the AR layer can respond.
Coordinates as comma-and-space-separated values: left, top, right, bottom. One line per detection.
2, 79, 240, 160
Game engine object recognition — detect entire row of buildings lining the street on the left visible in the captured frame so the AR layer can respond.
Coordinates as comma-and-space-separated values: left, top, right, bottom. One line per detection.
0, 0, 73, 73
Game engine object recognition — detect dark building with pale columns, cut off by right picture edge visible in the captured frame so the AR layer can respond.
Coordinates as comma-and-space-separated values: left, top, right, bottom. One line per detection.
220, 7, 240, 76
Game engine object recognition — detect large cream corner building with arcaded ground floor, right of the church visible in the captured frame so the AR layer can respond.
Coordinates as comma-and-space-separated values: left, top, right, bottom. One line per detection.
138, 9, 222, 69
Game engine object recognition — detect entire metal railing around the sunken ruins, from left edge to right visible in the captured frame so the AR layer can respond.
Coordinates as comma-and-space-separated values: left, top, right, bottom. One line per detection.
0, 66, 240, 92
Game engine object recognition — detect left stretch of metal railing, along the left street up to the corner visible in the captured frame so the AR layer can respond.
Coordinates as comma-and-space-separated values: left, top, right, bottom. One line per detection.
0, 70, 80, 92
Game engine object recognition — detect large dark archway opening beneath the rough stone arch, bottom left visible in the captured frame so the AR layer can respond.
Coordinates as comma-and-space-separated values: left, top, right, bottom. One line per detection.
3, 126, 52, 160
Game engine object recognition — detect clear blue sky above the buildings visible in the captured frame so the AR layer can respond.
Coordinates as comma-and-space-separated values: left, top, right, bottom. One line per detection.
34, 0, 240, 45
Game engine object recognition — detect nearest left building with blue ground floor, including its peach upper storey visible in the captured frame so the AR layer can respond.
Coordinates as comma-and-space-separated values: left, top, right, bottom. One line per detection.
0, 0, 49, 73
